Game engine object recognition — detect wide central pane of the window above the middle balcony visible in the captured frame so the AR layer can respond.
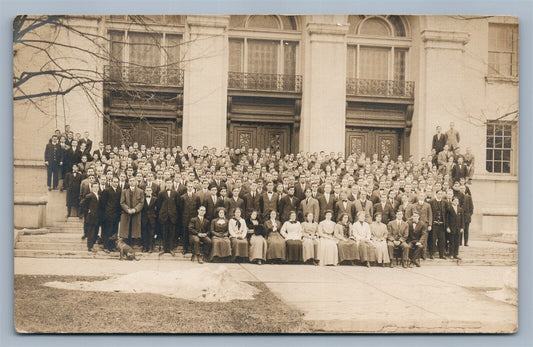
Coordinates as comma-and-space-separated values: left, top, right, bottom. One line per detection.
248, 40, 279, 74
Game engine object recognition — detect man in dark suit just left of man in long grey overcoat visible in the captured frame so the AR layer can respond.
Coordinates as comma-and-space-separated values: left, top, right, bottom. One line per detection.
102, 177, 121, 253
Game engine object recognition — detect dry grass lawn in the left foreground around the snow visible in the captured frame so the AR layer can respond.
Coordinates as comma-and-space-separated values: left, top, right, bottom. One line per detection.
14, 275, 309, 333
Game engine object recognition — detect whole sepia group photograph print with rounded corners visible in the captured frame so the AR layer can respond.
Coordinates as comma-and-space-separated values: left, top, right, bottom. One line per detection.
13, 13, 520, 334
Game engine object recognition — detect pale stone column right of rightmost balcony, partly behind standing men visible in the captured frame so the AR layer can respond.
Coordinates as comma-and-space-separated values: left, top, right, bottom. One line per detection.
411, 16, 470, 158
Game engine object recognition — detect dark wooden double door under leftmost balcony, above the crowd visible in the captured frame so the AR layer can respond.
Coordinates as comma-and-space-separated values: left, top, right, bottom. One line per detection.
104, 117, 181, 147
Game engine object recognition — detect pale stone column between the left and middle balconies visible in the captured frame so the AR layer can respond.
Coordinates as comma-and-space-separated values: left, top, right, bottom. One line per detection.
183, 16, 229, 150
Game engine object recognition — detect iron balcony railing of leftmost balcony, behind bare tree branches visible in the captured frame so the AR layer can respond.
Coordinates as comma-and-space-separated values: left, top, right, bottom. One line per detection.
104, 65, 183, 87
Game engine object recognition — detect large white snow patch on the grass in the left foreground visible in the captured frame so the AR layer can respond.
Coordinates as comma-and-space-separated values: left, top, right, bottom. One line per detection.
44, 266, 259, 302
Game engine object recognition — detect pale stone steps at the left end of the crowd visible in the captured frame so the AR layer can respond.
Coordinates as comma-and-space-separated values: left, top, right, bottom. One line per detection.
14, 217, 190, 260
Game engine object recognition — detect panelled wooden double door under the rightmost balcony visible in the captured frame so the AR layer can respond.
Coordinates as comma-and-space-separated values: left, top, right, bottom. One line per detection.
346, 127, 403, 160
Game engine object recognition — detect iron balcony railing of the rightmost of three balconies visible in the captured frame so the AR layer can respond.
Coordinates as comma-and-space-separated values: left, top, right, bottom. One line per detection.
346, 78, 415, 99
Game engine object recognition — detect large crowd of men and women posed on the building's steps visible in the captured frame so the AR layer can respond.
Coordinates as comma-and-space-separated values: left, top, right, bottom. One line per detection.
45, 123, 474, 267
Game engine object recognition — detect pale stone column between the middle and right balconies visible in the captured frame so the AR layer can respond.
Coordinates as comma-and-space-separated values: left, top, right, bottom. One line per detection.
300, 15, 349, 153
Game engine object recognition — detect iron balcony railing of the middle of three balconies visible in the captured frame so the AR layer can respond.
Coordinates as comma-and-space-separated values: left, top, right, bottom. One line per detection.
228, 72, 302, 93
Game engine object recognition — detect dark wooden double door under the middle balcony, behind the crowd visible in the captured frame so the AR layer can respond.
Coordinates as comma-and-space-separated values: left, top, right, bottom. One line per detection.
228, 122, 292, 154
